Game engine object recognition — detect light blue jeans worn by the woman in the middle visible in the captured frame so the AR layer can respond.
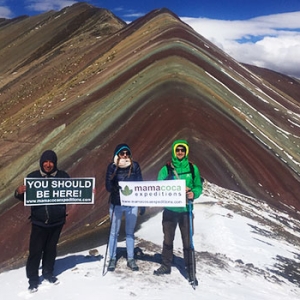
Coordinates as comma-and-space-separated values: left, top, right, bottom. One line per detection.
109, 204, 138, 259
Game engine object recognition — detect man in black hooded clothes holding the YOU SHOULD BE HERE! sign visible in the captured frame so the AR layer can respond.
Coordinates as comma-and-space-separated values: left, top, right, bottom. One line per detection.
15, 150, 70, 292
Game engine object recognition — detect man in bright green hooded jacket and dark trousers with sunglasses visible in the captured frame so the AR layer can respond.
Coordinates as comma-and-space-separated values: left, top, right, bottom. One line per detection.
154, 140, 202, 284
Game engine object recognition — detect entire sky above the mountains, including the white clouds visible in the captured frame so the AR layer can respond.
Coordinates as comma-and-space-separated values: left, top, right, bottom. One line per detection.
0, 0, 300, 78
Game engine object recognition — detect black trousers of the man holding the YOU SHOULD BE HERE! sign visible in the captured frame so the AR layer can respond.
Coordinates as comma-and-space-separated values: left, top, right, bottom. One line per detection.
26, 224, 63, 284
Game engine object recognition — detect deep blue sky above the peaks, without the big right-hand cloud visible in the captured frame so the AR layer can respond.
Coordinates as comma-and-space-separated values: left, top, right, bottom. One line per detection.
0, 0, 300, 20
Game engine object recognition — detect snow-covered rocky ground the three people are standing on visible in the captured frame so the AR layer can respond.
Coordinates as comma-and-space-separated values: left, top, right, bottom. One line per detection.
0, 183, 300, 300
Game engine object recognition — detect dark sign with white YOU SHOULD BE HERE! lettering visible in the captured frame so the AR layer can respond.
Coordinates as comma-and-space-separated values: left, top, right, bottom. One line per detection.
24, 178, 95, 206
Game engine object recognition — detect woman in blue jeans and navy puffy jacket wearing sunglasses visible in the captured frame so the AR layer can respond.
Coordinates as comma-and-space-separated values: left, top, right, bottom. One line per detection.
105, 144, 145, 271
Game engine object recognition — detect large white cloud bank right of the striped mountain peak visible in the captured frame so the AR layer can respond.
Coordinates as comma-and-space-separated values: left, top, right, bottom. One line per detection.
181, 12, 300, 78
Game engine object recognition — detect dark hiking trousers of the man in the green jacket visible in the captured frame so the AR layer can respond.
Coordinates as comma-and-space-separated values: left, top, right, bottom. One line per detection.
162, 209, 194, 272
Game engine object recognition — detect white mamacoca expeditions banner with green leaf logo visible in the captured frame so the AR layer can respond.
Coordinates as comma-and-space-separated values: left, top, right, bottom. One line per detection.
119, 179, 186, 207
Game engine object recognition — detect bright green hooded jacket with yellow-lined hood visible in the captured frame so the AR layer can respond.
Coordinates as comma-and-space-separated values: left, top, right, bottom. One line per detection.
157, 140, 202, 212
